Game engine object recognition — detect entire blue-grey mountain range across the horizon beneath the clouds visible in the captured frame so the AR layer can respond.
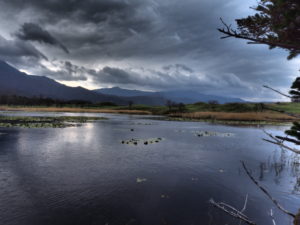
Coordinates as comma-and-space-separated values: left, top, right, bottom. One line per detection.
0, 60, 243, 105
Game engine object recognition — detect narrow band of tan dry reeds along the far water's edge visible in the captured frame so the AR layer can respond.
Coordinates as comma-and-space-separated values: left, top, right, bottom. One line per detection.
0, 106, 299, 126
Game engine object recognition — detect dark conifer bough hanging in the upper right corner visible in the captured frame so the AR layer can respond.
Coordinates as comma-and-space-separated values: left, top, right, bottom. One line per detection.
218, 0, 300, 59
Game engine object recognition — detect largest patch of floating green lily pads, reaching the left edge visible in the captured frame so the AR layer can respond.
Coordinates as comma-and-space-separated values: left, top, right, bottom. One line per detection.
0, 116, 106, 128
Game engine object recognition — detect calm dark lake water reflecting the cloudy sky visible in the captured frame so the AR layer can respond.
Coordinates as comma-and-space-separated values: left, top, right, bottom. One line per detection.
0, 113, 300, 225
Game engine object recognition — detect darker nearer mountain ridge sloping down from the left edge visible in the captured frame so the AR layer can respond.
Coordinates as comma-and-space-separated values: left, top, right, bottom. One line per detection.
0, 61, 165, 105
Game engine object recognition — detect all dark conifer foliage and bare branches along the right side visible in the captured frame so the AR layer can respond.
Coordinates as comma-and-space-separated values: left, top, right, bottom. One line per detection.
211, 0, 300, 225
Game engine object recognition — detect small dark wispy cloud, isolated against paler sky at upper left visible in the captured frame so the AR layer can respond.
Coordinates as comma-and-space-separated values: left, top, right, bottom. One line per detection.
16, 23, 69, 53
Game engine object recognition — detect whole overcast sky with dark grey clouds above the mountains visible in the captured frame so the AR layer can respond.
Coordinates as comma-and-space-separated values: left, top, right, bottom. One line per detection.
0, 0, 300, 100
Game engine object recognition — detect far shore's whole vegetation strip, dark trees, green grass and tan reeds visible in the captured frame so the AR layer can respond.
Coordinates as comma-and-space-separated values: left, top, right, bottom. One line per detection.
0, 95, 300, 124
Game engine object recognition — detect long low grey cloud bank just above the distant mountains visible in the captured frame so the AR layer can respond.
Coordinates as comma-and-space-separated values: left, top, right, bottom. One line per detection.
87, 64, 250, 96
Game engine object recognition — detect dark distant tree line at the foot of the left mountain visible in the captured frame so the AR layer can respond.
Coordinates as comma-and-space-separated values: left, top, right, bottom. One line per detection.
0, 95, 116, 107
